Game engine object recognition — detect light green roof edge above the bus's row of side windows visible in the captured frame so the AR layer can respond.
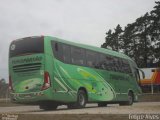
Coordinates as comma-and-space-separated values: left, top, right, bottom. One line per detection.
44, 36, 134, 62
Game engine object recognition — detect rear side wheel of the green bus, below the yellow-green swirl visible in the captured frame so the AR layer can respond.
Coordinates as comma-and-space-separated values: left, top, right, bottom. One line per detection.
76, 90, 87, 108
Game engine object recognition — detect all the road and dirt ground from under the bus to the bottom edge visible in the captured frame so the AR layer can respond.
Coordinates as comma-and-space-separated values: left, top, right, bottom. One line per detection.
0, 102, 160, 120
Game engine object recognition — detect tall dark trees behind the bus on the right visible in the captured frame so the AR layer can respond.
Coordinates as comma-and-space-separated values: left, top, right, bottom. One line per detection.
101, 1, 160, 67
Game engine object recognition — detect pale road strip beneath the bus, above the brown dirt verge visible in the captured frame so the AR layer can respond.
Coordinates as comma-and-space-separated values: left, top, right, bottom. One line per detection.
0, 102, 160, 114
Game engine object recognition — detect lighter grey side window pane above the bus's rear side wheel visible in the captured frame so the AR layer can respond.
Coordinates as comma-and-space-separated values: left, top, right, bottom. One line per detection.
71, 46, 85, 65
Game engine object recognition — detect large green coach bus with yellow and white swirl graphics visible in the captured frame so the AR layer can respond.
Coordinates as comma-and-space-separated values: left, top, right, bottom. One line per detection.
9, 36, 144, 110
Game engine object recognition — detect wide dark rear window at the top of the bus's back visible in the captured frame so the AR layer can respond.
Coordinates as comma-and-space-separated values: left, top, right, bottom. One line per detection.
9, 37, 44, 57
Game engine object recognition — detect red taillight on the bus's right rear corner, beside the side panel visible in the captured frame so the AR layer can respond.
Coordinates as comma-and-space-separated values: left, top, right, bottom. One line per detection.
41, 72, 51, 90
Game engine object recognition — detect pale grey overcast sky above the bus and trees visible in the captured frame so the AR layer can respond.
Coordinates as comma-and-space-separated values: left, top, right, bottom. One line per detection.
0, 0, 155, 81
